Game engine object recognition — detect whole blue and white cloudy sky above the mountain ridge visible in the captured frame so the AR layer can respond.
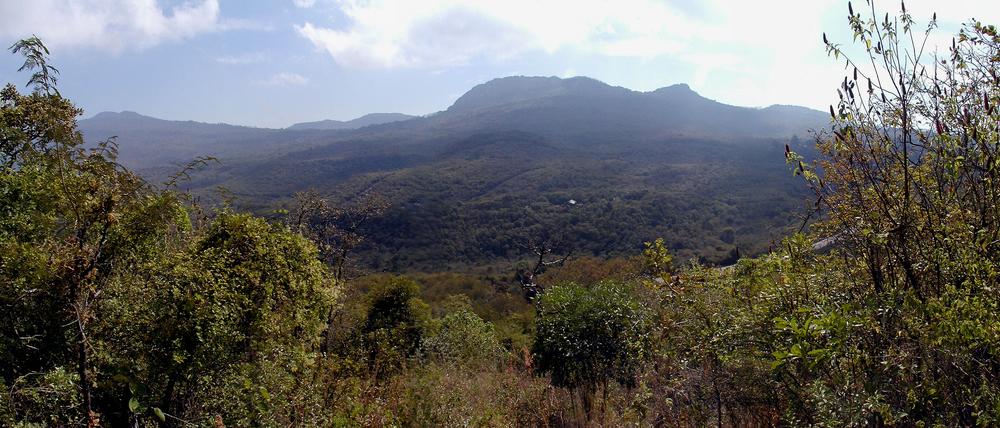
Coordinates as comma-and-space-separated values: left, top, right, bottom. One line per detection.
0, 0, 1000, 127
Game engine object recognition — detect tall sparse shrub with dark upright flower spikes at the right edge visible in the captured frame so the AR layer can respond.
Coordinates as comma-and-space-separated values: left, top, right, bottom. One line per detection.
776, 2, 1000, 425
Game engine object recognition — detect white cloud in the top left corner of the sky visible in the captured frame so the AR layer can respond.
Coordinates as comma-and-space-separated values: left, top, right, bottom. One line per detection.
0, 0, 230, 52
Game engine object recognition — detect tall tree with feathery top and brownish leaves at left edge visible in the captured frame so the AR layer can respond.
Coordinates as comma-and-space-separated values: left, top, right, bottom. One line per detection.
0, 38, 188, 424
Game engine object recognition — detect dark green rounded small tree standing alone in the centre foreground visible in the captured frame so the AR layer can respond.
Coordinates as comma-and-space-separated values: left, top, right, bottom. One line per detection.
533, 282, 652, 418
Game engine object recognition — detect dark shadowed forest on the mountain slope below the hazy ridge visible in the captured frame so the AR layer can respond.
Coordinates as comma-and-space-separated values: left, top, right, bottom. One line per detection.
256, 133, 811, 273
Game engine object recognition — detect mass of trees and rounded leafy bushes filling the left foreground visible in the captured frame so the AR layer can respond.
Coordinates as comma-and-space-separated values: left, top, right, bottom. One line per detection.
0, 39, 336, 426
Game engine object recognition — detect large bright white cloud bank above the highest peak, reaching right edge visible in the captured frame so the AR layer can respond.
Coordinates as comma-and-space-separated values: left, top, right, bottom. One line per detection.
296, 0, 1000, 108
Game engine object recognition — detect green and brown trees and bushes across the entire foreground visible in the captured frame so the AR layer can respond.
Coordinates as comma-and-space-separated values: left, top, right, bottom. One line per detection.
0, 3, 1000, 427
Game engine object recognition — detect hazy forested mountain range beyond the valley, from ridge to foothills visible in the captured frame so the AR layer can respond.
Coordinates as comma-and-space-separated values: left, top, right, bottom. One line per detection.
80, 77, 828, 270
